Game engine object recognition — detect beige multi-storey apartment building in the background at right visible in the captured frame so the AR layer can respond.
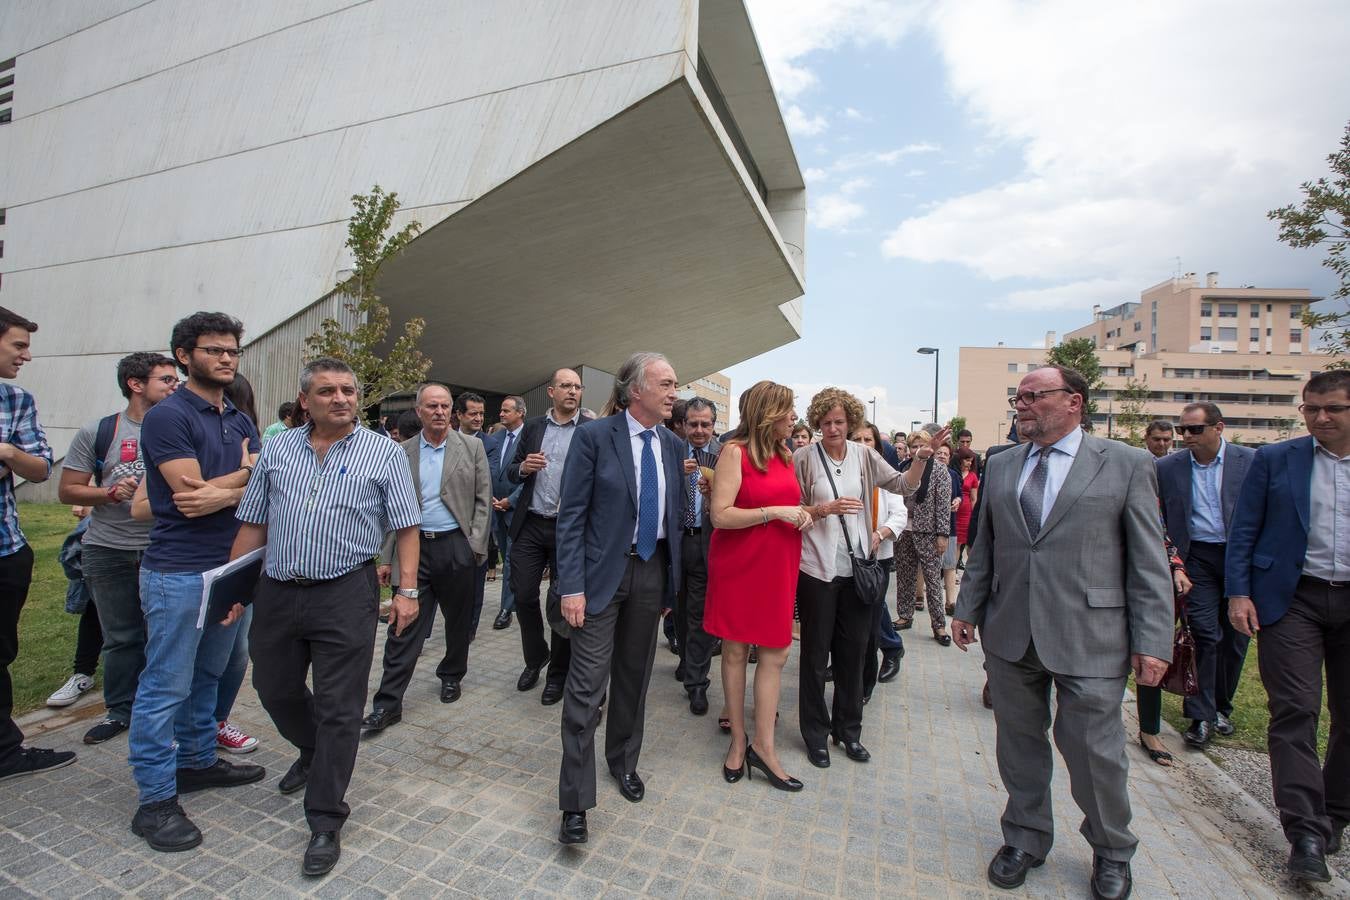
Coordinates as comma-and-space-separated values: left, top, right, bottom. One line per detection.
957, 273, 1324, 448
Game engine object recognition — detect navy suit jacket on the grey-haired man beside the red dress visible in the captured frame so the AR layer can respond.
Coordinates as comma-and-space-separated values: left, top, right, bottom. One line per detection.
558, 412, 686, 614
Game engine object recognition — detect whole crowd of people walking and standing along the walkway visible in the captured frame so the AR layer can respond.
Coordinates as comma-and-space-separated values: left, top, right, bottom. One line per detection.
0, 309, 1350, 897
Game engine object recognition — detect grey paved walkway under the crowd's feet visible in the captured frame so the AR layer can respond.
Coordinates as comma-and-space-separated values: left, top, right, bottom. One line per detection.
0, 584, 1350, 899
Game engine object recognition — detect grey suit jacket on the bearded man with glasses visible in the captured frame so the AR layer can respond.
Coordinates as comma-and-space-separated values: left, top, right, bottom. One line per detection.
956, 434, 1172, 677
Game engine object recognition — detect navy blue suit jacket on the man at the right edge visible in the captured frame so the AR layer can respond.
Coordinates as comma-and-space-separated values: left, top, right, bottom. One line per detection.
1224, 436, 1314, 625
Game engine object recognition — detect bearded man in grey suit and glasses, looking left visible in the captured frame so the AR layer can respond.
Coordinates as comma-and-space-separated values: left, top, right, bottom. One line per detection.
952, 366, 1172, 900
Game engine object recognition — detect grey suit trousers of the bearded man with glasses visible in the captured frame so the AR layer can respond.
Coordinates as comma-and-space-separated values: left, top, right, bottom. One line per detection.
984, 646, 1138, 862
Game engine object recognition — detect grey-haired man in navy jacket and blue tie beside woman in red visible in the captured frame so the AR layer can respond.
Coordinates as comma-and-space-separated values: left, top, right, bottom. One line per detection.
558, 352, 686, 843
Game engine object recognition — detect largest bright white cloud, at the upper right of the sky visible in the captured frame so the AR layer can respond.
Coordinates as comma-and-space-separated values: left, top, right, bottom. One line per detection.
882, 0, 1350, 295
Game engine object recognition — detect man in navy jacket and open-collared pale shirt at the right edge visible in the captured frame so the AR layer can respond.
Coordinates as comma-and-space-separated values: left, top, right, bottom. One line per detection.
1226, 368, 1350, 881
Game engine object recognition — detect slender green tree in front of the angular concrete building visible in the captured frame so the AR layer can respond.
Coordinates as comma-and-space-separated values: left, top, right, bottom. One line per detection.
305, 185, 431, 406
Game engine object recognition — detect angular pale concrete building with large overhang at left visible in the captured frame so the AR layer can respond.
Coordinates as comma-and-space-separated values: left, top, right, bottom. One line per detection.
0, 0, 806, 472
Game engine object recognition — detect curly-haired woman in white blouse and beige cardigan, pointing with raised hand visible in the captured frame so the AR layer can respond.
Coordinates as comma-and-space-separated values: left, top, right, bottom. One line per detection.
792, 387, 949, 769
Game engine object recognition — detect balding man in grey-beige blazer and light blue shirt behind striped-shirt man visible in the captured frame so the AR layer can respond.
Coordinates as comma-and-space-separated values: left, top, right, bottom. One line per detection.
362, 383, 493, 735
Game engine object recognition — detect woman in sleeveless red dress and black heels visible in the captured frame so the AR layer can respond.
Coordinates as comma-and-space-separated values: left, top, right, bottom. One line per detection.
703, 382, 811, 791
